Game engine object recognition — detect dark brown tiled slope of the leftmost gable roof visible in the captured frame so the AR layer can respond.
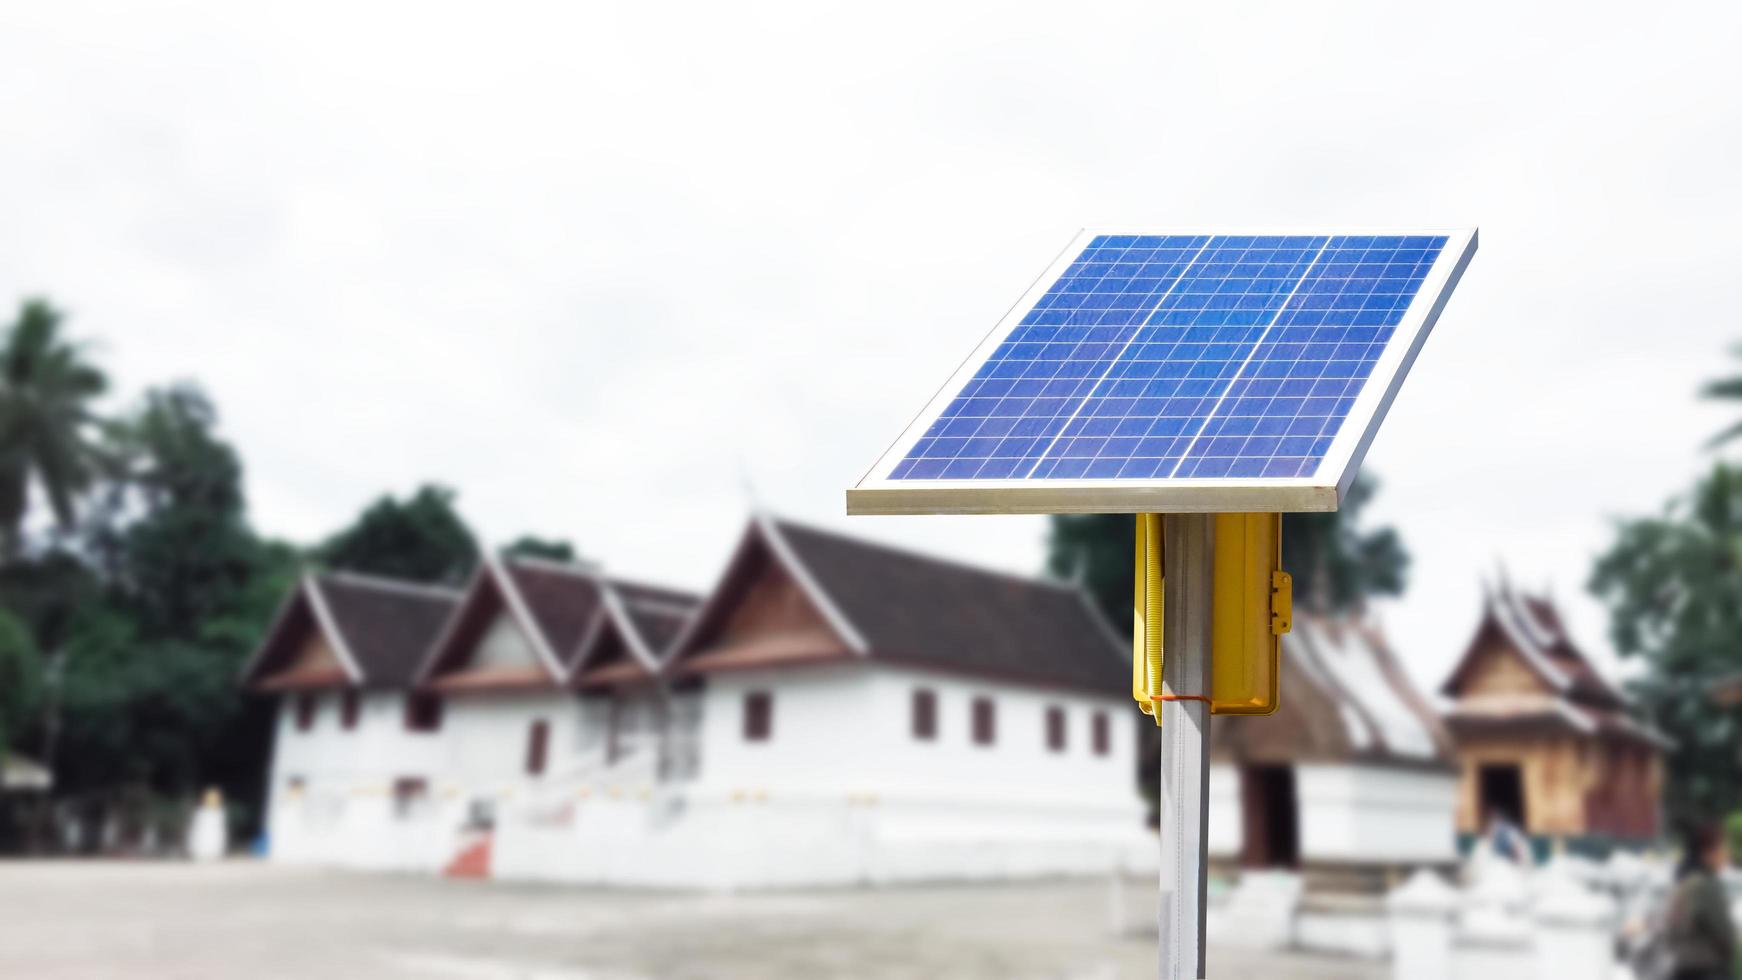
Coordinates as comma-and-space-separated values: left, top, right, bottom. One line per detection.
317, 573, 458, 688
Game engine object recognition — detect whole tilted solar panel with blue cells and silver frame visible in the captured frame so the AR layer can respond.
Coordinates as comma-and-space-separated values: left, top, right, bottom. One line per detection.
848, 230, 1475, 513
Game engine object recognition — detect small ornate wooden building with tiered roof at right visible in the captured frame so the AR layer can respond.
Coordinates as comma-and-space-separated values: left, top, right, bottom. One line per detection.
1442, 581, 1667, 844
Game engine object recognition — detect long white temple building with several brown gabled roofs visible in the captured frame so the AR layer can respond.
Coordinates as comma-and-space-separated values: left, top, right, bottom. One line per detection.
244, 517, 1157, 888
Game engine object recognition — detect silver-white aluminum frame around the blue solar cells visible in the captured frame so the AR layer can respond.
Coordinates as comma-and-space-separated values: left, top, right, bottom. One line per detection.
847, 228, 1477, 513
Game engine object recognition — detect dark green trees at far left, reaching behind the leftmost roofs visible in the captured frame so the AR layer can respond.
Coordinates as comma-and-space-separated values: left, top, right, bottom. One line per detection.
0, 301, 573, 842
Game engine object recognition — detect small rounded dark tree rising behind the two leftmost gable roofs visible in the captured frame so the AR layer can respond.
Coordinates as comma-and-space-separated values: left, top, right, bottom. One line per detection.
317, 484, 477, 583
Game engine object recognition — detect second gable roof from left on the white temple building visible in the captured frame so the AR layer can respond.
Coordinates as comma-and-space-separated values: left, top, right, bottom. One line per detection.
416, 555, 601, 686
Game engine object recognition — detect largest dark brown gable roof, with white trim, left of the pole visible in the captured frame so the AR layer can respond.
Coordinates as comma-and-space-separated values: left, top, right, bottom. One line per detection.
671, 513, 1131, 695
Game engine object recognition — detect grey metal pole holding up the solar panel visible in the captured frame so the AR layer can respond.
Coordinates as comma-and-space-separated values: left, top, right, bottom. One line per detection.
1158, 513, 1216, 980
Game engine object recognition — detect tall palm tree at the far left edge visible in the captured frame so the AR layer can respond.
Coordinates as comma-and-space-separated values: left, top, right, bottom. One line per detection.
0, 299, 108, 557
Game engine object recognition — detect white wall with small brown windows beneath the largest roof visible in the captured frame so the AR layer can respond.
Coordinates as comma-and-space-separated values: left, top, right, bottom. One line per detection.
495, 663, 1157, 888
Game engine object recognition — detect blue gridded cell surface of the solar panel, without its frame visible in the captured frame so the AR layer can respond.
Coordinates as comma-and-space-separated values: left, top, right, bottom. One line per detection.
890, 235, 1446, 480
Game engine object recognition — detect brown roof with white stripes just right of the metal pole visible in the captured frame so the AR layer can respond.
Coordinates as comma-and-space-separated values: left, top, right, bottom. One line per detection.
1211, 611, 1453, 768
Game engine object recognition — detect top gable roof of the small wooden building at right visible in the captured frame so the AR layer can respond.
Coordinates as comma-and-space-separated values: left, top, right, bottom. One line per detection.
1441, 578, 1629, 708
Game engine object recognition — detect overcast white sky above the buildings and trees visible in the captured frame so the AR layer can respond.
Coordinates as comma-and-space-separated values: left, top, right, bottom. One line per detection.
0, 0, 1742, 682
